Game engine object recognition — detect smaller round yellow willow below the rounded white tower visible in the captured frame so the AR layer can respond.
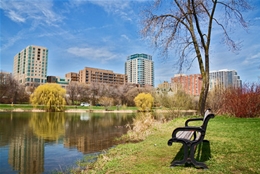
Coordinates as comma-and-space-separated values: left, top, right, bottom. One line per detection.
134, 93, 154, 111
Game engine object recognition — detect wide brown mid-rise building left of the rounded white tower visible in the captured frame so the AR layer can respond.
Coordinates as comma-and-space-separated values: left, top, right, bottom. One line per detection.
79, 67, 127, 85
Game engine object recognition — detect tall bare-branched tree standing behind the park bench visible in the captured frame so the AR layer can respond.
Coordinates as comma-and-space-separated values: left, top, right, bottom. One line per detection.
142, 0, 251, 115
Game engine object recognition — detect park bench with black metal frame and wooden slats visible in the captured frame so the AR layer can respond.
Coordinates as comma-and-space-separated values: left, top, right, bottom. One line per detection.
168, 109, 215, 169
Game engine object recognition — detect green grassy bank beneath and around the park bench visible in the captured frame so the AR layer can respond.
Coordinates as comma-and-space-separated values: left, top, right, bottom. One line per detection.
84, 116, 260, 174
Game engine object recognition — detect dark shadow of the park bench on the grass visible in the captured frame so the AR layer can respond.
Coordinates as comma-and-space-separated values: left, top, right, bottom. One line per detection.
171, 140, 211, 167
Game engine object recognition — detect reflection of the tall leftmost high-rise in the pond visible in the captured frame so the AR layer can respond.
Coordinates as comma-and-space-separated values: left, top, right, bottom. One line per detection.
8, 133, 44, 174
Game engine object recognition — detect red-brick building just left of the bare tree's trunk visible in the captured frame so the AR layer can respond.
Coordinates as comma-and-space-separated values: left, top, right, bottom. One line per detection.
171, 74, 202, 96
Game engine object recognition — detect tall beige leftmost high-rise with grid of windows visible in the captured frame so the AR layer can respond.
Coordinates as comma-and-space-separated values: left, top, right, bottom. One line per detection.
13, 45, 48, 86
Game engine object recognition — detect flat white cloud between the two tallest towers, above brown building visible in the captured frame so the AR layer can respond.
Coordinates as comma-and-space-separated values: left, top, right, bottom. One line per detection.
67, 47, 117, 63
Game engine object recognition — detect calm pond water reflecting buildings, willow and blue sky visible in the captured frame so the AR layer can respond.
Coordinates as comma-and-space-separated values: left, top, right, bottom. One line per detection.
0, 112, 134, 174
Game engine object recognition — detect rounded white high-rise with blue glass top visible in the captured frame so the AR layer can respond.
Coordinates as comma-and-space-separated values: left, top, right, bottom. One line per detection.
125, 54, 154, 86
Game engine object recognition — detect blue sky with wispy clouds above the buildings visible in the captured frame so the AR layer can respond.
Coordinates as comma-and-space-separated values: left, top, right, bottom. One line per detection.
0, 0, 260, 86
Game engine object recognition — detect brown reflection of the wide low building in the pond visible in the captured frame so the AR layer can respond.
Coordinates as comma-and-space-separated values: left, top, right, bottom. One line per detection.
63, 117, 132, 154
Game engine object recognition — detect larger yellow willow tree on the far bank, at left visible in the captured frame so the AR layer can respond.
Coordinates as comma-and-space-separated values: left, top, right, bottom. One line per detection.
30, 83, 66, 112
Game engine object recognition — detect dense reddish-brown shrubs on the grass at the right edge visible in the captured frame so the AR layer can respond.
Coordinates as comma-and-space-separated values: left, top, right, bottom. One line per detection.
208, 83, 260, 117
